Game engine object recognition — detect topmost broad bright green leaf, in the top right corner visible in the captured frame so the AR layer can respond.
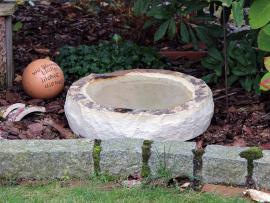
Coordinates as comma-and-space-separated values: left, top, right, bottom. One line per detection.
249, 0, 270, 29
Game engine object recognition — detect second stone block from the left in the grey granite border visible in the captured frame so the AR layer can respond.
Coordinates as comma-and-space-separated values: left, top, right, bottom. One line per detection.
100, 139, 143, 177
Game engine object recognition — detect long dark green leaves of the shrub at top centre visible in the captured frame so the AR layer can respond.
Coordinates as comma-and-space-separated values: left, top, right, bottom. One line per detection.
134, 0, 221, 48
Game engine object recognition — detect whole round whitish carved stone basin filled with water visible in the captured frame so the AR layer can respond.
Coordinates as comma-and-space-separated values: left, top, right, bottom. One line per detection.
65, 69, 214, 141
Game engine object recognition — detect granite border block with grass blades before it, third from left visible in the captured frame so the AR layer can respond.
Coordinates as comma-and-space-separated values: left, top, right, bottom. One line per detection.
148, 141, 196, 177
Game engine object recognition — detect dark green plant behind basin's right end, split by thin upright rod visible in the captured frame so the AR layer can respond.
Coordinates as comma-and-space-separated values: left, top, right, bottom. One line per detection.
202, 40, 259, 92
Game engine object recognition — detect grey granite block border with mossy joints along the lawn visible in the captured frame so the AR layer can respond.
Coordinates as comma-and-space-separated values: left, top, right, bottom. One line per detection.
0, 139, 270, 189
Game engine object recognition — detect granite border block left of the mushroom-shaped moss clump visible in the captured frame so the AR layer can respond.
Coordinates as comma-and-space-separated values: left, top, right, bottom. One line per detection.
202, 145, 247, 185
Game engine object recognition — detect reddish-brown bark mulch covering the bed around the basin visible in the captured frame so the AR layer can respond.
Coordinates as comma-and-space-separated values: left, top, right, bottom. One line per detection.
0, 1, 270, 149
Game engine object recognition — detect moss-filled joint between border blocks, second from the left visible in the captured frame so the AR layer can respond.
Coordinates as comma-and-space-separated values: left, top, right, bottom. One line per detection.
141, 140, 153, 178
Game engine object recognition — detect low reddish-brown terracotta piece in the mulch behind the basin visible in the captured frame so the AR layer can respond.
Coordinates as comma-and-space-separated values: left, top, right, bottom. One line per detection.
159, 51, 207, 60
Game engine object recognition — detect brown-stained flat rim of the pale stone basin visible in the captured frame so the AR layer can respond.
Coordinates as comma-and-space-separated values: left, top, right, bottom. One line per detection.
67, 69, 212, 115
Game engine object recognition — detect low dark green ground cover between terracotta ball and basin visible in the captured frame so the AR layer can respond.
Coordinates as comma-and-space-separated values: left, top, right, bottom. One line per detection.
56, 39, 166, 77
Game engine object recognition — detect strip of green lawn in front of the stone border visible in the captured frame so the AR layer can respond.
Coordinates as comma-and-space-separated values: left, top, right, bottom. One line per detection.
0, 181, 251, 203
